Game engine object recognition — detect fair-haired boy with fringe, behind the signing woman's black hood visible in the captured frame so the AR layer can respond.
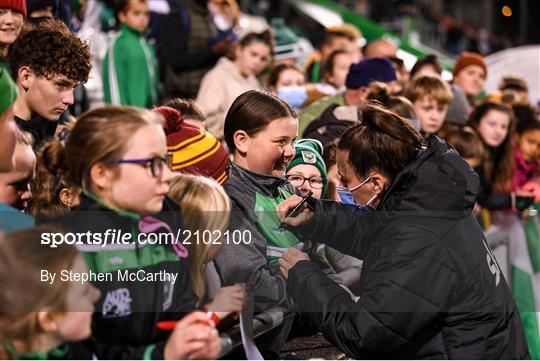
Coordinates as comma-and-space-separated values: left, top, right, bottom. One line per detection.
405, 76, 453, 138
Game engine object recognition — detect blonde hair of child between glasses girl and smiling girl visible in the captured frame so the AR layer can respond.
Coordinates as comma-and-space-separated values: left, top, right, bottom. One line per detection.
169, 174, 231, 302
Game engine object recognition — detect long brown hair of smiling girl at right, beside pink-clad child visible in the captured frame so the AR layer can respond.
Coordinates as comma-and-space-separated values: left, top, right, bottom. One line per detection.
469, 103, 515, 192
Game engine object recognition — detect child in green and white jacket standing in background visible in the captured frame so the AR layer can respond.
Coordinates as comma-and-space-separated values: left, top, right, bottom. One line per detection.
103, 0, 159, 108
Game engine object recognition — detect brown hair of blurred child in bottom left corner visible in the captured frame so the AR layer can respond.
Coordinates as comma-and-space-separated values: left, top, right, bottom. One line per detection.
0, 227, 79, 359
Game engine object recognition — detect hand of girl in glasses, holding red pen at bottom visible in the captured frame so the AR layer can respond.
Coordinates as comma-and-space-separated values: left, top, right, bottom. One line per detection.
163, 312, 221, 360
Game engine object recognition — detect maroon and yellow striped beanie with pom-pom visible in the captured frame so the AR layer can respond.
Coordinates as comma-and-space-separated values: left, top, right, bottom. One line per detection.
154, 107, 229, 184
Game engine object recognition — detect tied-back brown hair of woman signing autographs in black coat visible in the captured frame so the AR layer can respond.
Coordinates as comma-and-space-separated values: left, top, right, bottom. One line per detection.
338, 104, 423, 179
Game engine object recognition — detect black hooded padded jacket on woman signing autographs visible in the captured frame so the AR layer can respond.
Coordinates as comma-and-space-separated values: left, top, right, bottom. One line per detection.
287, 137, 529, 359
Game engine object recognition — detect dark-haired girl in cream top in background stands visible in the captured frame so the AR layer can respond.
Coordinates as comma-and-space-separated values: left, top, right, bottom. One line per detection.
197, 31, 273, 139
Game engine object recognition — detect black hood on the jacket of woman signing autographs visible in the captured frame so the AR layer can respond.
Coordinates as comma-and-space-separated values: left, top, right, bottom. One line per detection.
379, 136, 480, 218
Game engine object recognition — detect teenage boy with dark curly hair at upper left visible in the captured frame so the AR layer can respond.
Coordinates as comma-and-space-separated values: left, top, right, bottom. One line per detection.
10, 19, 91, 149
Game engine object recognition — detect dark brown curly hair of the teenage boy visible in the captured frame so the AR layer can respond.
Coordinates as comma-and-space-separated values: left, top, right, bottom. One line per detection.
9, 19, 92, 82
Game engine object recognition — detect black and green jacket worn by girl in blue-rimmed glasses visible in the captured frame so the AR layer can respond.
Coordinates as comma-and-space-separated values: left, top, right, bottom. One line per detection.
55, 192, 197, 360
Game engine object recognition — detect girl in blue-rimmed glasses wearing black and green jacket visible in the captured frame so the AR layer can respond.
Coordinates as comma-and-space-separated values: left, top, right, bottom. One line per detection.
48, 106, 220, 359
